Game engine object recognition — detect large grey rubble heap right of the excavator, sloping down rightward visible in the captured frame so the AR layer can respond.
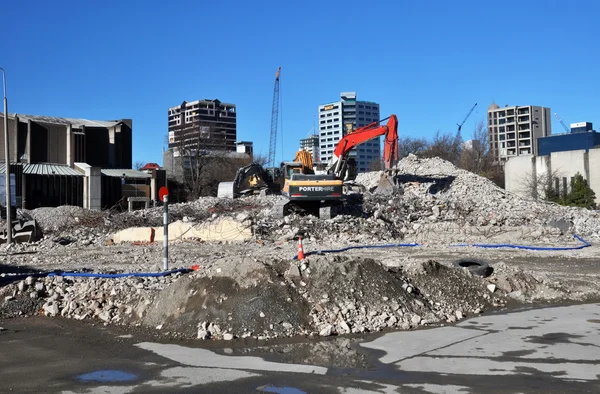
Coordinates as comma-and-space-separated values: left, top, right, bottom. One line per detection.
357, 155, 600, 238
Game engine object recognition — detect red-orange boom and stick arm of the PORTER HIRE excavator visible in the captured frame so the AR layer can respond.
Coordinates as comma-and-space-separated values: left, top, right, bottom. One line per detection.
327, 115, 398, 178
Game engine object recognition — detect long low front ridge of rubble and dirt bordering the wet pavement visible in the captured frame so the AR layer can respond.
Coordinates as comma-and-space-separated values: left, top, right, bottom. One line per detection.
0, 252, 563, 340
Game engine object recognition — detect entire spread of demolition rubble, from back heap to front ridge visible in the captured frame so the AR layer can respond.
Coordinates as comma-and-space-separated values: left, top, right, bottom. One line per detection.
0, 156, 600, 340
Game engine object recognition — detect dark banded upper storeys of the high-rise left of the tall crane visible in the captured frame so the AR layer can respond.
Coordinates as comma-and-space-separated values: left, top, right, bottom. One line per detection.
169, 99, 237, 151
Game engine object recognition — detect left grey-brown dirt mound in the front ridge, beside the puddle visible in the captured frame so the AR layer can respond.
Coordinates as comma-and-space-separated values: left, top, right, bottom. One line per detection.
142, 263, 308, 339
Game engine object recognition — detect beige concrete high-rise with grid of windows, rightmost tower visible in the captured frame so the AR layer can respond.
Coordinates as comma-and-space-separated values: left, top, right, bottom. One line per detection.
488, 103, 552, 163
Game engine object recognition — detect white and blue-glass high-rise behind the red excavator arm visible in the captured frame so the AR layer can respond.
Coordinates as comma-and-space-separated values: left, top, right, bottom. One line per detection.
319, 92, 381, 172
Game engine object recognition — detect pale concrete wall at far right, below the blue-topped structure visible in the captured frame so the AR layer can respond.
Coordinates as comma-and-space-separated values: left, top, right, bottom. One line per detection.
504, 148, 600, 203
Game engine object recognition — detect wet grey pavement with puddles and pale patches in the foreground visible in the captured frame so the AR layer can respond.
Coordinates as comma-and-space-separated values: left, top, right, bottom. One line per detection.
0, 304, 600, 394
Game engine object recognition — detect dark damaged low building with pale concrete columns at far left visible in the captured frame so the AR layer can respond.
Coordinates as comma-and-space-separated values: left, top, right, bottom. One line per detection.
0, 114, 164, 209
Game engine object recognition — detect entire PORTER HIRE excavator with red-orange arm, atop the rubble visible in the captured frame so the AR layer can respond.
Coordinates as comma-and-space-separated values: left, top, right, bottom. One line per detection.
273, 115, 398, 218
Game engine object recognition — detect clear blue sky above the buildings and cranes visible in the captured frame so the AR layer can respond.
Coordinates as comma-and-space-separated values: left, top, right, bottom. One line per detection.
0, 0, 600, 164
